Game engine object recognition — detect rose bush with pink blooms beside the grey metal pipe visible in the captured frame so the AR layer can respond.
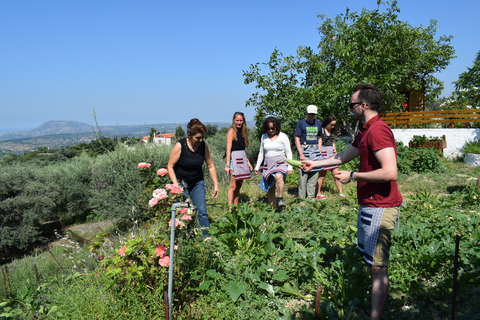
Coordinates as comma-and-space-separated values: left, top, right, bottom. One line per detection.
97, 162, 194, 290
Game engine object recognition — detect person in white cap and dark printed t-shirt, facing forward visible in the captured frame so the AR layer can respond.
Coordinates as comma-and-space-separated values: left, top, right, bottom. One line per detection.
295, 104, 322, 200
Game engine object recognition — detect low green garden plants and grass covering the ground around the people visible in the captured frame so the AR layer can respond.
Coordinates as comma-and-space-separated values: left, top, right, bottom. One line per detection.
0, 156, 480, 319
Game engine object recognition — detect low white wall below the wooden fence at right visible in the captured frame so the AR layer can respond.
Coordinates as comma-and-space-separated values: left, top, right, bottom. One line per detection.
392, 128, 480, 159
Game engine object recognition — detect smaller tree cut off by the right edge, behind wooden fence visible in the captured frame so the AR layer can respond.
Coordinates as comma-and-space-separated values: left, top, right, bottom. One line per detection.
455, 51, 480, 107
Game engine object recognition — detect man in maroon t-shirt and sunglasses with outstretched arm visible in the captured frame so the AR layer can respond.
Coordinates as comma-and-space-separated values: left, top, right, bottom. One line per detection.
303, 84, 403, 319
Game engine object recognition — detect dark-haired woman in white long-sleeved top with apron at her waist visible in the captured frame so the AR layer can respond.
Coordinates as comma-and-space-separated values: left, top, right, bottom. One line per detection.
255, 117, 292, 208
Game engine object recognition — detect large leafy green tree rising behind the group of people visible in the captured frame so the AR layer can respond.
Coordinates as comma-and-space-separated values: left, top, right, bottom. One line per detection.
244, 0, 455, 136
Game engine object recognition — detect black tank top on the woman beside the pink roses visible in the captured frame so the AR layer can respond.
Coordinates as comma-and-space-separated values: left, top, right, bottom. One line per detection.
173, 138, 205, 184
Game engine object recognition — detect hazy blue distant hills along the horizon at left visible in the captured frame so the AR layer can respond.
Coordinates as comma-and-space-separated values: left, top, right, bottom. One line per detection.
0, 120, 231, 153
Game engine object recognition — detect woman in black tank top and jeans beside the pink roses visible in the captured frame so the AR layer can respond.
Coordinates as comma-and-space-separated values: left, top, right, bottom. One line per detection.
167, 119, 218, 237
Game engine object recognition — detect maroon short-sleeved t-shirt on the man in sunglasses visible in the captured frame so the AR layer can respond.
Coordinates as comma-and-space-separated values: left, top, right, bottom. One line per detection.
352, 115, 403, 208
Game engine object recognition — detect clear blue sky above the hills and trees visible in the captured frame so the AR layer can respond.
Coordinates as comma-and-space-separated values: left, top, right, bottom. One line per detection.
0, 0, 480, 132
